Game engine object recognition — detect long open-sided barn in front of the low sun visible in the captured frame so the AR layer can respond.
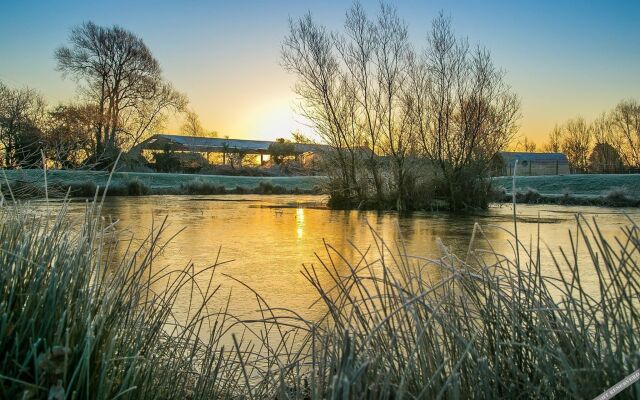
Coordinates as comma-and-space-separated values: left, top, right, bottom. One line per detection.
129, 134, 326, 165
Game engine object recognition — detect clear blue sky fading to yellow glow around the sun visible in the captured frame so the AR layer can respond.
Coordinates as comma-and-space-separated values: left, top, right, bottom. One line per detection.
0, 0, 640, 143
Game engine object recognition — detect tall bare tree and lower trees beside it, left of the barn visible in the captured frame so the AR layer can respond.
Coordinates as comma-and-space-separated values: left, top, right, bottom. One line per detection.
0, 22, 197, 168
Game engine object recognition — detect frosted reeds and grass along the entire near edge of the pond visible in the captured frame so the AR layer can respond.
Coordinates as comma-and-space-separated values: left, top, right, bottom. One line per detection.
0, 191, 640, 399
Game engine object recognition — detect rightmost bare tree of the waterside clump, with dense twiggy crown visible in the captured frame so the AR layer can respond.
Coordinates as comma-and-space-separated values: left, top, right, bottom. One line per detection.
414, 14, 519, 210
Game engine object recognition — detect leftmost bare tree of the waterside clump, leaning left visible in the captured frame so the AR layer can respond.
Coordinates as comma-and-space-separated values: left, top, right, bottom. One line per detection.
282, 14, 362, 203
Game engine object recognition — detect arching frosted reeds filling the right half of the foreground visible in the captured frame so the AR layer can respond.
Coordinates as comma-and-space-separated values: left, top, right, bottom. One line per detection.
288, 216, 640, 399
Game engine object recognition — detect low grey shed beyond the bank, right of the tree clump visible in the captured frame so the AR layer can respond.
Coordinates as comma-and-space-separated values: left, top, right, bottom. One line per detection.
491, 151, 571, 176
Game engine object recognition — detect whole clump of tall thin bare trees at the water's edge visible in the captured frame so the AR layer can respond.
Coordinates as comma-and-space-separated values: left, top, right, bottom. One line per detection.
282, 4, 519, 211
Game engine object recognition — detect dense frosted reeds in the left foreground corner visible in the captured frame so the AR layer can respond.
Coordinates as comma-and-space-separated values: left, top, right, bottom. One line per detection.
0, 195, 292, 399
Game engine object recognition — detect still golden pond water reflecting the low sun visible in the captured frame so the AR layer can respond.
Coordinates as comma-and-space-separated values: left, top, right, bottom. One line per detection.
63, 195, 640, 320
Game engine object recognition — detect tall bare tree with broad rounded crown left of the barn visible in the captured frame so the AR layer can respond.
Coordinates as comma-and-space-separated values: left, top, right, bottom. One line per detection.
55, 22, 186, 166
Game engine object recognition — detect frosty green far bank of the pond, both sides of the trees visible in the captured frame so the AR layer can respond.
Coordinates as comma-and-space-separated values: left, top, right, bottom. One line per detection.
0, 169, 640, 209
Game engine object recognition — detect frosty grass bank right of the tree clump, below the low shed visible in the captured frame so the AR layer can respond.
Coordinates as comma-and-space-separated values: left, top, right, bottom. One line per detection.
493, 174, 640, 199
